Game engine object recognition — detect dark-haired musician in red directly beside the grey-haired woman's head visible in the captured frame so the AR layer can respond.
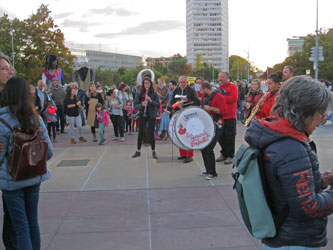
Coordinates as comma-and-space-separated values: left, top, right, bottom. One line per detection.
255, 72, 282, 119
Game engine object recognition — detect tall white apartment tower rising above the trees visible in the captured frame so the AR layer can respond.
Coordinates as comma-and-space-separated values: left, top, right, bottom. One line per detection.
186, 0, 229, 72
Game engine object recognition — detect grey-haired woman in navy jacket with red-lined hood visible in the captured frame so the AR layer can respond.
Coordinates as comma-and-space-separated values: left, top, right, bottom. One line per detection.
245, 76, 333, 250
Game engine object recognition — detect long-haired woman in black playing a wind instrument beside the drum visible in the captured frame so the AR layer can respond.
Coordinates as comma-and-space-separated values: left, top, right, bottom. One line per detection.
132, 78, 160, 159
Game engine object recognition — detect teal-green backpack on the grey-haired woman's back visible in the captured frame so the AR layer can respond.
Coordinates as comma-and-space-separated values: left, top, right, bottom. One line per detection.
232, 144, 288, 239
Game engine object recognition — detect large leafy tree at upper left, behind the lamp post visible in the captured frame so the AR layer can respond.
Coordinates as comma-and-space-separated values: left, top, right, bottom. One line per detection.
0, 4, 74, 83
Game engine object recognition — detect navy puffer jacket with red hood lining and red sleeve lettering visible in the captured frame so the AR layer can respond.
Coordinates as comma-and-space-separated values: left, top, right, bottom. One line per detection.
245, 118, 333, 247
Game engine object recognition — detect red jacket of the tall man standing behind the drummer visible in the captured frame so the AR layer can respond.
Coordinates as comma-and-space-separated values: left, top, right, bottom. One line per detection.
220, 82, 238, 120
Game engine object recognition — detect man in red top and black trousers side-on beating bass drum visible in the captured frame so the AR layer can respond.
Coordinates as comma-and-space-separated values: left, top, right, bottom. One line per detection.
200, 82, 228, 180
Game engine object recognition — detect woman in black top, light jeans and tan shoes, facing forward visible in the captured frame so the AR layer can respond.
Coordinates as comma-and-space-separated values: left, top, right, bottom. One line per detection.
64, 87, 87, 144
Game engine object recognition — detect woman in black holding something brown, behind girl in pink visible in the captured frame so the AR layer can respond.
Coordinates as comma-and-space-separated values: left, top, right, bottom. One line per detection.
84, 82, 105, 142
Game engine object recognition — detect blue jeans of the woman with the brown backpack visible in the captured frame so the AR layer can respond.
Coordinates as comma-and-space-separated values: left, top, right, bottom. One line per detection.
2, 184, 40, 250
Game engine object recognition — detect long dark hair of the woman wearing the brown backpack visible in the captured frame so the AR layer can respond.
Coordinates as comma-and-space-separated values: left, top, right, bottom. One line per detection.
0, 77, 39, 133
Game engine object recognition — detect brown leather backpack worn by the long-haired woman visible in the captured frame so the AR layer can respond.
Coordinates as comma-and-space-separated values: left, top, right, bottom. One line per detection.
0, 118, 48, 181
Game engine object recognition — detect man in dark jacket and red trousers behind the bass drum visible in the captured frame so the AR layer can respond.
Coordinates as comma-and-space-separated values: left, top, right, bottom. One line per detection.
171, 76, 200, 163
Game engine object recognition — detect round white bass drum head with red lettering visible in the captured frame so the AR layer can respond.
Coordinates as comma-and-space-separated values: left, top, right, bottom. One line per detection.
174, 107, 215, 150
